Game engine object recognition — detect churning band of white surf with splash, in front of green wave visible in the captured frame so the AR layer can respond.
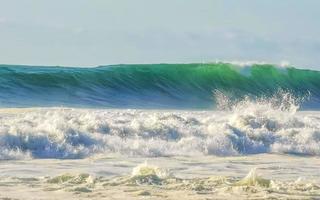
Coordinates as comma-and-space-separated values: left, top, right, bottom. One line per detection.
0, 94, 320, 159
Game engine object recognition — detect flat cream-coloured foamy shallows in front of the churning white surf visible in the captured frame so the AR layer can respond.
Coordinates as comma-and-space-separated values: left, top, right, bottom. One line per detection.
0, 154, 320, 199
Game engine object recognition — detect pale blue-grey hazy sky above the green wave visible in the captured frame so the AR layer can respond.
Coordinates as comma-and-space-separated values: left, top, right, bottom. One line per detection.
0, 0, 320, 69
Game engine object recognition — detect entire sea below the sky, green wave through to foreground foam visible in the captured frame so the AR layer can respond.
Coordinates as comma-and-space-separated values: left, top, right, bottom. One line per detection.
0, 63, 320, 199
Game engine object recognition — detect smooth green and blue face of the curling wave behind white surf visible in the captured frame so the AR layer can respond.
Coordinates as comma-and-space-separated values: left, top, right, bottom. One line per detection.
0, 63, 320, 109
